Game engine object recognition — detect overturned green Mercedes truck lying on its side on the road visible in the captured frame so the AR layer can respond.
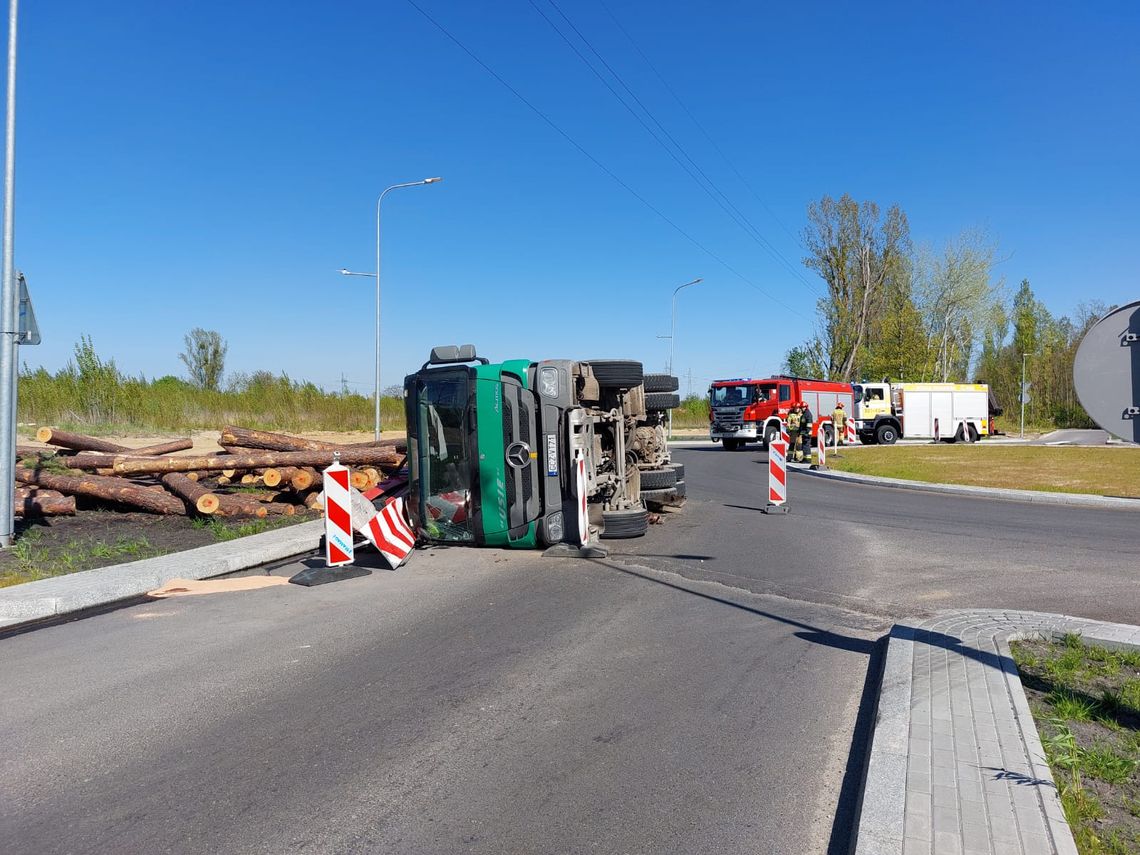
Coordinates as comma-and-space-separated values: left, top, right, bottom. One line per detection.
404, 344, 685, 548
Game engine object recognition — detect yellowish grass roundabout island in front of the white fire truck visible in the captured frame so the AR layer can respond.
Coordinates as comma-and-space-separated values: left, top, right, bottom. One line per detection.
828, 442, 1140, 498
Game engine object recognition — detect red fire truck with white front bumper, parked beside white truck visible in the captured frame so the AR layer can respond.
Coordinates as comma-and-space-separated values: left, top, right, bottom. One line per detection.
709, 374, 855, 451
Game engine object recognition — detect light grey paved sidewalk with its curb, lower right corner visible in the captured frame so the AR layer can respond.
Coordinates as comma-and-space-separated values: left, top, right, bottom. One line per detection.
855, 609, 1140, 855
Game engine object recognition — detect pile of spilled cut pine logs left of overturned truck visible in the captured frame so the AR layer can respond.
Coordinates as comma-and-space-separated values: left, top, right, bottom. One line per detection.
15, 426, 407, 516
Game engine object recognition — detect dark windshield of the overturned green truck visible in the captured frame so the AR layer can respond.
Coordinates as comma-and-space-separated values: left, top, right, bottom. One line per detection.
409, 369, 474, 542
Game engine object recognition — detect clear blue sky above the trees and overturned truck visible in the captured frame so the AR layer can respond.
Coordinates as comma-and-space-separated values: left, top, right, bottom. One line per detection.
16, 0, 1140, 392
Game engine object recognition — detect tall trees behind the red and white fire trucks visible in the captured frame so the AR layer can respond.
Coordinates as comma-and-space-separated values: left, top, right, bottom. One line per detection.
783, 194, 1109, 428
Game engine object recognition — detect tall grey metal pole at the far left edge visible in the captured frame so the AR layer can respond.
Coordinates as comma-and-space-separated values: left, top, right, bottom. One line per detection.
0, 0, 19, 548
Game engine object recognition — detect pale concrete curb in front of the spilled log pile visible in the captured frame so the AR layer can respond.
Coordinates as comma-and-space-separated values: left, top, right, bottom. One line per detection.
0, 520, 325, 628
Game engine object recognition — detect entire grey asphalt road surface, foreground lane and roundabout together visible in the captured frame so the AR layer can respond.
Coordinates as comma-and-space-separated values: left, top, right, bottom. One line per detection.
0, 448, 1140, 855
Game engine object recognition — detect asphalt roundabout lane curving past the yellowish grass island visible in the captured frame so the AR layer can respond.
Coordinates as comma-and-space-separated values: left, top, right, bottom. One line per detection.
632, 443, 1140, 624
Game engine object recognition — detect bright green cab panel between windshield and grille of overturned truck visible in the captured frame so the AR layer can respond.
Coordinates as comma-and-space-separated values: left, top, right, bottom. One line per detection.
475, 359, 538, 549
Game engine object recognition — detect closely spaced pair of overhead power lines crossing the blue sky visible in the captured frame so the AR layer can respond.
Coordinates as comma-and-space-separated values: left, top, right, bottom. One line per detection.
538, 0, 823, 296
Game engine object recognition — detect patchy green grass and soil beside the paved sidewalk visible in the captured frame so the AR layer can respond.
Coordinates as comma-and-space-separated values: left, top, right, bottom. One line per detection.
1010, 636, 1140, 855
